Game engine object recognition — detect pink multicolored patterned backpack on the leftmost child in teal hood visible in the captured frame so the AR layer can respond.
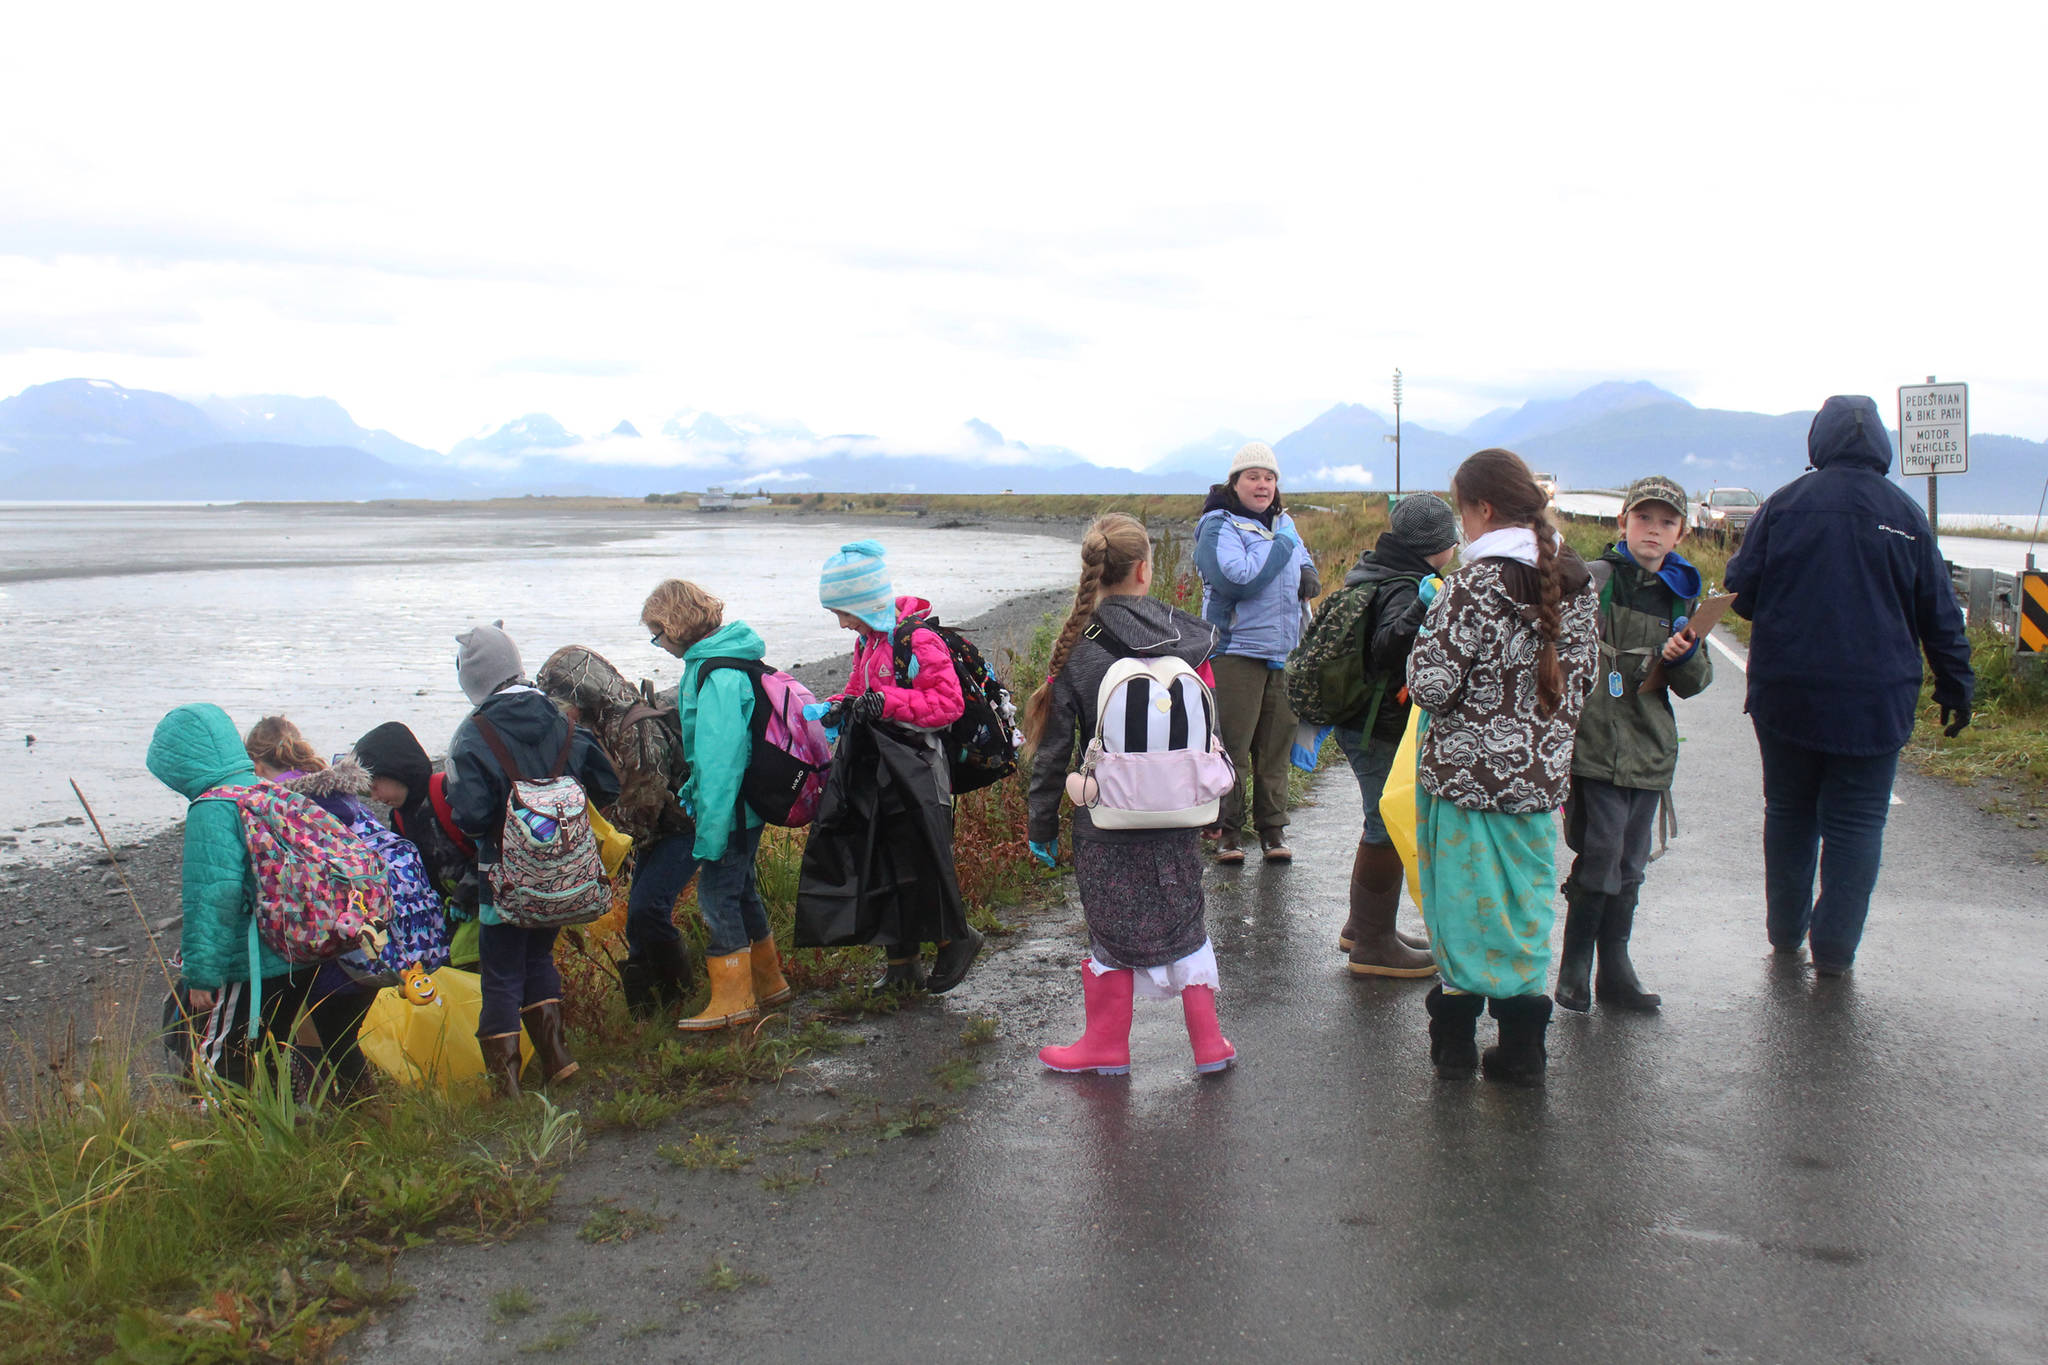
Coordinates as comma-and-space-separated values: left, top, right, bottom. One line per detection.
197, 780, 391, 972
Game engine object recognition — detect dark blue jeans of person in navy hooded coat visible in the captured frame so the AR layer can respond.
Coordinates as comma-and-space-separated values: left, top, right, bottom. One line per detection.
1757, 726, 1898, 966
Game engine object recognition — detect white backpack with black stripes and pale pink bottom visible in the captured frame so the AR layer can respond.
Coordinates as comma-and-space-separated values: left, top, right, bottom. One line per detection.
1067, 624, 1237, 829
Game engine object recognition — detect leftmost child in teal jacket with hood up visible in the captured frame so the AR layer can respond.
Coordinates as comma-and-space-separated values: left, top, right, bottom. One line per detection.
145, 702, 354, 1089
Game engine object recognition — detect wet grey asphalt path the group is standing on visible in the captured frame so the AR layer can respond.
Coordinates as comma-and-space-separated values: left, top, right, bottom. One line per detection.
356, 634, 2048, 1363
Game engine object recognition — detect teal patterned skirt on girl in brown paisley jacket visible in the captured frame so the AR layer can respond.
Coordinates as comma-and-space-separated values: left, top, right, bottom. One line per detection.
1415, 786, 1556, 999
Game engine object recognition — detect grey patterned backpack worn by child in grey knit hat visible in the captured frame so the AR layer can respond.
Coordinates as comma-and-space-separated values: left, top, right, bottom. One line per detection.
471, 716, 612, 929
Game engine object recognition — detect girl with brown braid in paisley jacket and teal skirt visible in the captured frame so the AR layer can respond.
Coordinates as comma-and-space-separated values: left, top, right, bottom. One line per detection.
1407, 450, 1597, 1085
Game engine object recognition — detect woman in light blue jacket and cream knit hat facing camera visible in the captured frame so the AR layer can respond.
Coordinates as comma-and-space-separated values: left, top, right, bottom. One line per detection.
1194, 440, 1323, 864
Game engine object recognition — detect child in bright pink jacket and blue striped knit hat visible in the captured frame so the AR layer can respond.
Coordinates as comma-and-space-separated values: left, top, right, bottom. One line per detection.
817, 540, 981, 993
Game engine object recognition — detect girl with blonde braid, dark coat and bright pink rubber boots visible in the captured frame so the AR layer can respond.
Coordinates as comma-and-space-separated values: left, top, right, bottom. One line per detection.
1024, 512, 1237, 1076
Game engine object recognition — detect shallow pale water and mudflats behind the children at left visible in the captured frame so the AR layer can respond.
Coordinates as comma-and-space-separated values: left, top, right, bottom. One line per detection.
0, 505, 1077, 862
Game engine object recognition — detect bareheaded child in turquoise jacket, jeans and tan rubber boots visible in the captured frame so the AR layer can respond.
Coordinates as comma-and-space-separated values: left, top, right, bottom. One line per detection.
641, 579, 795, 1033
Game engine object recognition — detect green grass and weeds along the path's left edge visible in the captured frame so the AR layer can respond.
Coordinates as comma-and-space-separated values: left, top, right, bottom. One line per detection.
0, 620, 1059, 1365
